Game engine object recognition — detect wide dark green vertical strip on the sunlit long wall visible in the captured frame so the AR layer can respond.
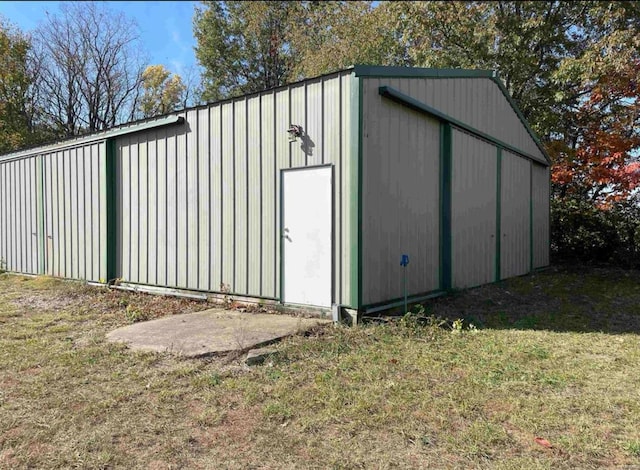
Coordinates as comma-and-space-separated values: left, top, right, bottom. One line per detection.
103, 139, 118, 282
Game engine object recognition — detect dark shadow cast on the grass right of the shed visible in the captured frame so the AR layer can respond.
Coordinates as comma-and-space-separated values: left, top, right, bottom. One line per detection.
426, 265, 640, 334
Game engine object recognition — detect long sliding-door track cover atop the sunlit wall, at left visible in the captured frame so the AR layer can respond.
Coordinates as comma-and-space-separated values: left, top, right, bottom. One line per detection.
0, 115, 185, 162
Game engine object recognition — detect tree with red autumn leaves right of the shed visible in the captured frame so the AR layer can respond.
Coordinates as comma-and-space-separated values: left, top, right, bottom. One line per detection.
549, 60, 640, 206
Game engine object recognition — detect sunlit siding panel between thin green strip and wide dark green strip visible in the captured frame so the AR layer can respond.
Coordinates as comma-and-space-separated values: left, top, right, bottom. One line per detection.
42, 142, 106, 282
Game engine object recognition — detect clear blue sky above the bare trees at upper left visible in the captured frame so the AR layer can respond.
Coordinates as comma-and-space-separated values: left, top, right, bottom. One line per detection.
0, 1, 199, 76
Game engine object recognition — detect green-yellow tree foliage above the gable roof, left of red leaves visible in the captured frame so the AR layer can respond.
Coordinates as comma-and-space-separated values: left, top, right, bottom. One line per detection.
390, 1, 640, 140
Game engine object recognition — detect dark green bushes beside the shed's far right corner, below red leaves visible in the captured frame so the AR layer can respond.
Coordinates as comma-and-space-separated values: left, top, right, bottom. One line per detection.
551, 198, 640, 266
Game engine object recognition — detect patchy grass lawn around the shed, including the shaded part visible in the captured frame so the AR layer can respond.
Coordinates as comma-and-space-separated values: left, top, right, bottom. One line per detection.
0, 268, 640, 469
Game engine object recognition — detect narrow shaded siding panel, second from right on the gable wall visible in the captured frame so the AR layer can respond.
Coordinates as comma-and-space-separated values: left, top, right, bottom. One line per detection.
500, 151, 531, 279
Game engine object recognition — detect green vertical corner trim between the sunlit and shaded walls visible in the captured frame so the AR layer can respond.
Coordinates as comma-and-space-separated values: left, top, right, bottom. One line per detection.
349, 74, 364, 311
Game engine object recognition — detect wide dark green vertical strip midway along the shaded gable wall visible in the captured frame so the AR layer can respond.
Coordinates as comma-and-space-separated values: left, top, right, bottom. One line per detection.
440, 122, 453, 291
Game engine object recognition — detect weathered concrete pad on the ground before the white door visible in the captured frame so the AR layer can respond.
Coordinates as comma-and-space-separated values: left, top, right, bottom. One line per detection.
107, 309, 331, 357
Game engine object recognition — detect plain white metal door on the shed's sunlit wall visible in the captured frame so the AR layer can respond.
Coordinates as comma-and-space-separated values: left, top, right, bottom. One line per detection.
282, 167, 333, 307
